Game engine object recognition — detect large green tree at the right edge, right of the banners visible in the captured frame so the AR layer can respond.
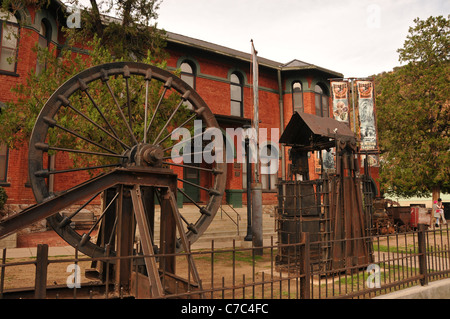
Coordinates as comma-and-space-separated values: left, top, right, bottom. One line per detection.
376, 16, 450, 199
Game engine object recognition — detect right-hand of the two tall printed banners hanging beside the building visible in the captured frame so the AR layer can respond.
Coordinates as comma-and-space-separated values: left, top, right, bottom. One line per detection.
356, 81, 377, 151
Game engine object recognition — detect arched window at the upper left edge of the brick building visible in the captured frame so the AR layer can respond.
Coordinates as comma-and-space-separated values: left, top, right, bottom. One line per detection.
0, 10, 19, 72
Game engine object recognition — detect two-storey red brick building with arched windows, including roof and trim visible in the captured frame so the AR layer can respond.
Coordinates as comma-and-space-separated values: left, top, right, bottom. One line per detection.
0, 1, 370, 212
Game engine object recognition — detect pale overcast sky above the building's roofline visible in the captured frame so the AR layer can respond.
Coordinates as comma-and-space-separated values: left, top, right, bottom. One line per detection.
157, 0, 450, 77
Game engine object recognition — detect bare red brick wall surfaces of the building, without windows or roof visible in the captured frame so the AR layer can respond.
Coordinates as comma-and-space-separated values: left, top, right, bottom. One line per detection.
0, 4, 366, 210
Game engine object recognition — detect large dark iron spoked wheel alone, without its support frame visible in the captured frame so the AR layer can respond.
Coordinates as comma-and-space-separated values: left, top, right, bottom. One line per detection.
28, 62, 226, 257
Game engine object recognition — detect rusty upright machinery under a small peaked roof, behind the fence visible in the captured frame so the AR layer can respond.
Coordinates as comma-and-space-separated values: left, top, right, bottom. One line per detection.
277, 113, 373, 271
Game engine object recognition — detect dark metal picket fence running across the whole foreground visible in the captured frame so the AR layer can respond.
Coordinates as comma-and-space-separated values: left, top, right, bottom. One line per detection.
0, 225, 450, 299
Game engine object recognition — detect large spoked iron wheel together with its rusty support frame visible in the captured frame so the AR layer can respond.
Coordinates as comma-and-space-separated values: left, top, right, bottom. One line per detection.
0, 62, 226, 296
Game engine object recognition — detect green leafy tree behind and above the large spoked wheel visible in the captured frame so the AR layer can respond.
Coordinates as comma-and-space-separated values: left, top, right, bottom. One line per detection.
0, 0, 188, 156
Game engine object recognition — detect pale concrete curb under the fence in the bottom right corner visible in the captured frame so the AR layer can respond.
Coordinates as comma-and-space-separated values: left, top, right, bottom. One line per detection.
373, 279, 450, 299
